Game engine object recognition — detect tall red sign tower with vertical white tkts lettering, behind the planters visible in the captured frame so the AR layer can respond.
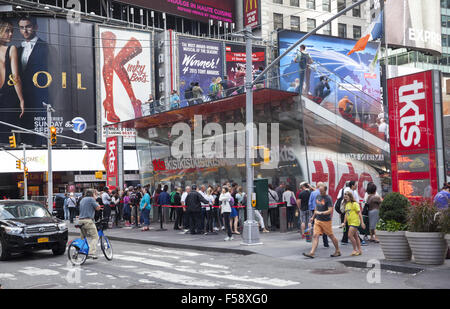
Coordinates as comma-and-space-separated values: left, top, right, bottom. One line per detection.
388, 70, 445, 199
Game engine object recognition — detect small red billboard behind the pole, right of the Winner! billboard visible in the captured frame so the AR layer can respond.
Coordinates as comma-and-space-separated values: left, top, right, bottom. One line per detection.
225, 44, 266, 92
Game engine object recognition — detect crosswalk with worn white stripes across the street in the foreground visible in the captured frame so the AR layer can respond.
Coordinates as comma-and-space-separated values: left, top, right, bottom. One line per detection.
0, 246, 301, 289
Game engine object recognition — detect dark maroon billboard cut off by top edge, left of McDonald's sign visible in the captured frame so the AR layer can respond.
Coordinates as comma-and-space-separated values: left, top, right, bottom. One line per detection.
116, 0, 235, 23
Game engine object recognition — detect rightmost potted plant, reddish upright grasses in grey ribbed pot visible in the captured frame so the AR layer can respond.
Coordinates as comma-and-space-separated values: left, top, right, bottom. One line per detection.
406, 199, 447, 265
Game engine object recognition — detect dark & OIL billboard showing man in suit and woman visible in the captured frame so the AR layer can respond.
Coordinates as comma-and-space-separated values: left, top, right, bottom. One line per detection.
0, 14, 96, 146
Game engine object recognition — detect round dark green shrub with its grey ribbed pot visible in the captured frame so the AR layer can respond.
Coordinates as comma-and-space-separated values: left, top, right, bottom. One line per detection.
377, 192, 411, 261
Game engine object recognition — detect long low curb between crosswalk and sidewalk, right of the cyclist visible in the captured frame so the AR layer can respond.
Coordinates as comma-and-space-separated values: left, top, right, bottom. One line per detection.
69, 232, 255, 255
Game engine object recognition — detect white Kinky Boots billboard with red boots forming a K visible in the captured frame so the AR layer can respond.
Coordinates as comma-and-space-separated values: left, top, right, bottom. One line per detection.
97, 26, 153, 143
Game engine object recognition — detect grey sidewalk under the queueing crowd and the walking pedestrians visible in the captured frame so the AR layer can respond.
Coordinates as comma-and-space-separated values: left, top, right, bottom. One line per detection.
69, 223, 450, 273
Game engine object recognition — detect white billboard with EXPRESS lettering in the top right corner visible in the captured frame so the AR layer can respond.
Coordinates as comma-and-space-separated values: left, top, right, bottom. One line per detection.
384, 0, 442, 54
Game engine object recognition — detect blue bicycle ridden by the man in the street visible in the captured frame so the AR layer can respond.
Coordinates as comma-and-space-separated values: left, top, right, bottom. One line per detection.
67, 220, 113, 266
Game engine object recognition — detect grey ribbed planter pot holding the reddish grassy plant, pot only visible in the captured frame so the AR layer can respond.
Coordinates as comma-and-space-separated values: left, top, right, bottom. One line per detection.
406, 232, 448, 265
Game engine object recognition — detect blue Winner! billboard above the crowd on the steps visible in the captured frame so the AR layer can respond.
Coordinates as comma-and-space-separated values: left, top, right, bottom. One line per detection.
178, 36, 224, 107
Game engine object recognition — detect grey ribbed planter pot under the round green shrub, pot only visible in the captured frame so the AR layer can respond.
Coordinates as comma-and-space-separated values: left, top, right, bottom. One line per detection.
376, 230, 411, 262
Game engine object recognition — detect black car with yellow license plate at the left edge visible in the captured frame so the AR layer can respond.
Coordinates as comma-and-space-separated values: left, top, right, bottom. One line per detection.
0, 200, 68, 261
